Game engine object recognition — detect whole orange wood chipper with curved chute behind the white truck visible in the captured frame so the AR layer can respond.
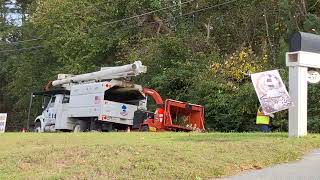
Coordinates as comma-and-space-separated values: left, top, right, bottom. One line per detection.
134, 88, 205, 132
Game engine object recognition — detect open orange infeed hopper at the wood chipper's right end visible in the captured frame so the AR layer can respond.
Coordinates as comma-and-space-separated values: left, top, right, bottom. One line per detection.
164, 99, 205, 132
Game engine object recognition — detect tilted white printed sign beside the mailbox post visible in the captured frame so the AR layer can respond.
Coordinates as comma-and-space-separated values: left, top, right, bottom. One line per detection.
251, 70, 293, 115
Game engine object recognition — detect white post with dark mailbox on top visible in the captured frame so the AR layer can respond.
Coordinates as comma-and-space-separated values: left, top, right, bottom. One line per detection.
286, 32, 320, 137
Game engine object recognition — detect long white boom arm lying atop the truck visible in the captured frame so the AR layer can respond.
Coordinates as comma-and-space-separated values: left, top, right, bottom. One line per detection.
52, 61, 147, 86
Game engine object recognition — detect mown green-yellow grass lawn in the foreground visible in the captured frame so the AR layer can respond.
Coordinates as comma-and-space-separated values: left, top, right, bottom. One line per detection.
0, 133, 320, 179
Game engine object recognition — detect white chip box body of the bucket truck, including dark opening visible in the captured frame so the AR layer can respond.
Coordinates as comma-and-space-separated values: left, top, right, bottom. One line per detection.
69, 82, 145, 121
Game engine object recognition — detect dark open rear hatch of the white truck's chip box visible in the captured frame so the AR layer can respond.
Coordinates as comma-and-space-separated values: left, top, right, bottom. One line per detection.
104, 86, 145, 106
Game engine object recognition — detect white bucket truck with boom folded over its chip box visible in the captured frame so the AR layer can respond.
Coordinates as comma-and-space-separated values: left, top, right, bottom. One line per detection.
28, 61, 147, 132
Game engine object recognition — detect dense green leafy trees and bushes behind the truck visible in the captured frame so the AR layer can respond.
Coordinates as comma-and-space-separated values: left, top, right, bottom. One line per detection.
0, 0, 320, 132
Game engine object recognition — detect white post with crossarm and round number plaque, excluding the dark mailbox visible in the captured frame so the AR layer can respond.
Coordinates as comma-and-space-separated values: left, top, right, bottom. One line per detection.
286, 51, 320, 137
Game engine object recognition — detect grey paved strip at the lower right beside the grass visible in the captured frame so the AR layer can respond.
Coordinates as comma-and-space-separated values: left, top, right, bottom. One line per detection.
224, 150, 320, 180
